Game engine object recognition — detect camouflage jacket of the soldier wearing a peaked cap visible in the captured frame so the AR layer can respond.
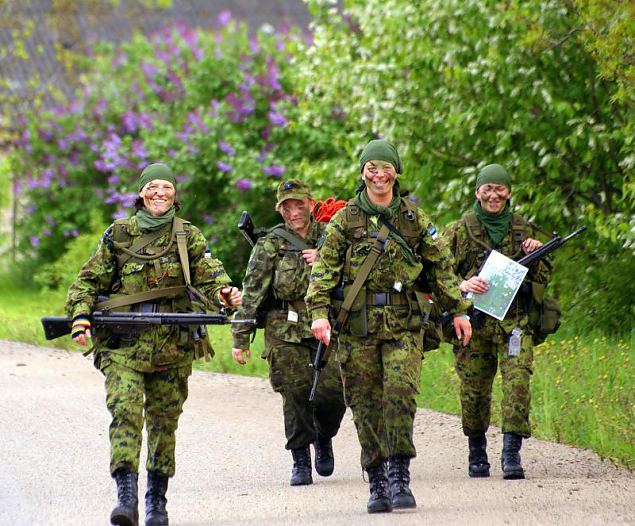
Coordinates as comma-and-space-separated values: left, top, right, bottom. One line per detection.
232, 221, 324, 349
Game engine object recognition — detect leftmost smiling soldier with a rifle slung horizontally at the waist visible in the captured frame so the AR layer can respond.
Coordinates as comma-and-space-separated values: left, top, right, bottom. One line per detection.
66, 163, 240, 526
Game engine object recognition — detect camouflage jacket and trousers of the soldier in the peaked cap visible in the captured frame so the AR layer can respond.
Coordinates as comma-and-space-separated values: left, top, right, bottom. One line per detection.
232, 221, 346, 450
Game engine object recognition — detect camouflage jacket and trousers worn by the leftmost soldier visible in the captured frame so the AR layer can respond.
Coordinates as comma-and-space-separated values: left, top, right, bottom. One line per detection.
66, 216, 230, 477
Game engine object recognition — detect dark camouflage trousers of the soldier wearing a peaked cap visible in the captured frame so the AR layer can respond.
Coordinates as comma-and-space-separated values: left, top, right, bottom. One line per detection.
265, 334, 346, 449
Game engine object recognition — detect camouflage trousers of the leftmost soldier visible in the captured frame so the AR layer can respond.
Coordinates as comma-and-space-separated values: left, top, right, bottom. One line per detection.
103, 362, 191, 477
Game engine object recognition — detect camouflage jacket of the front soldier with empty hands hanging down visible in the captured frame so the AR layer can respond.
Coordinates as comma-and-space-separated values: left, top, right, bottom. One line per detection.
306, 201, 470, 337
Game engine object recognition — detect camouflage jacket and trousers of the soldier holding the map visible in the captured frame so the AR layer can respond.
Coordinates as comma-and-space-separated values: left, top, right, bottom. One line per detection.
445, 212, 551, 438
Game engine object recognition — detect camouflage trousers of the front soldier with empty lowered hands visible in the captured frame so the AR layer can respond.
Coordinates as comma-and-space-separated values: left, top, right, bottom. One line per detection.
337, 331, 422, 469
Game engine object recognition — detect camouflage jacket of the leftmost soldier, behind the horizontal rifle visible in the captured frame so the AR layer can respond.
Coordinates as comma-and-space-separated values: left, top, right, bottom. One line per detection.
66, 216, 230, 372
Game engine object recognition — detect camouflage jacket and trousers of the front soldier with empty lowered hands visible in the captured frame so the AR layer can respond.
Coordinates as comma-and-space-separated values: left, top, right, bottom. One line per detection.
306, 198, 468, 469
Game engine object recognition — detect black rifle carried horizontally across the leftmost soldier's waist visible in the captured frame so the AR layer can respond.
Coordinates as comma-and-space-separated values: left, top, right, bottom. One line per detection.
42, 311, 256, 340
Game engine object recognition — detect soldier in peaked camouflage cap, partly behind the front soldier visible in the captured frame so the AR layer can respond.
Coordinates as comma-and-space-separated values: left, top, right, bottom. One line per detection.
232, 179, 346, 486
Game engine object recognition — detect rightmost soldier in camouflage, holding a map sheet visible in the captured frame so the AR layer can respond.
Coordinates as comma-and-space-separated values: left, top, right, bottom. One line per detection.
446, 164, 551, 479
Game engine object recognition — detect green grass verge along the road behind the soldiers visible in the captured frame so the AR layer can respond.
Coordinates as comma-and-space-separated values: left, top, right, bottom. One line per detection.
0, 276, 635, 469
